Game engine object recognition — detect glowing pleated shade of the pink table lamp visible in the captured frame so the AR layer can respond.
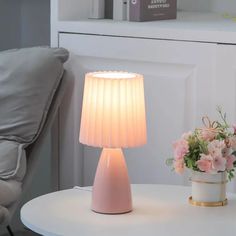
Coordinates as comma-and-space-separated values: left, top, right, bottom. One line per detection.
80, 71, 146, 148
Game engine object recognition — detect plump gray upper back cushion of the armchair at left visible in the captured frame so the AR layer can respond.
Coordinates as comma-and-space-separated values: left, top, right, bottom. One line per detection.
0, 47, 68, 143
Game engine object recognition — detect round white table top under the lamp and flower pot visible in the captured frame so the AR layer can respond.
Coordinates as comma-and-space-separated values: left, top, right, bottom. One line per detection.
21, 185, 236, 236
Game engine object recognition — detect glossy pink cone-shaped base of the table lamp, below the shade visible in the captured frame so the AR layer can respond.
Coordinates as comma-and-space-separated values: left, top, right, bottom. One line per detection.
92, 148, 132, 214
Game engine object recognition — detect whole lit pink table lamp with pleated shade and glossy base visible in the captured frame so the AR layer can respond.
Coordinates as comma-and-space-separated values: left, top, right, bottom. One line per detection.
80, 71, 146, 214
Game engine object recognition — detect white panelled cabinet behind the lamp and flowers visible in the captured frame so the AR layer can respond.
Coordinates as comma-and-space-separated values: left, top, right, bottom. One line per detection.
52, 0, 236, 188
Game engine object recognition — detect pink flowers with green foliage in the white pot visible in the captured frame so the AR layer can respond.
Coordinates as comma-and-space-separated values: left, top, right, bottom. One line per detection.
167, 108, 236, 180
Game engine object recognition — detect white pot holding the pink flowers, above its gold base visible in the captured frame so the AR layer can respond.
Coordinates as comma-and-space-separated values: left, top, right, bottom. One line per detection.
191, 171, 227, 203
